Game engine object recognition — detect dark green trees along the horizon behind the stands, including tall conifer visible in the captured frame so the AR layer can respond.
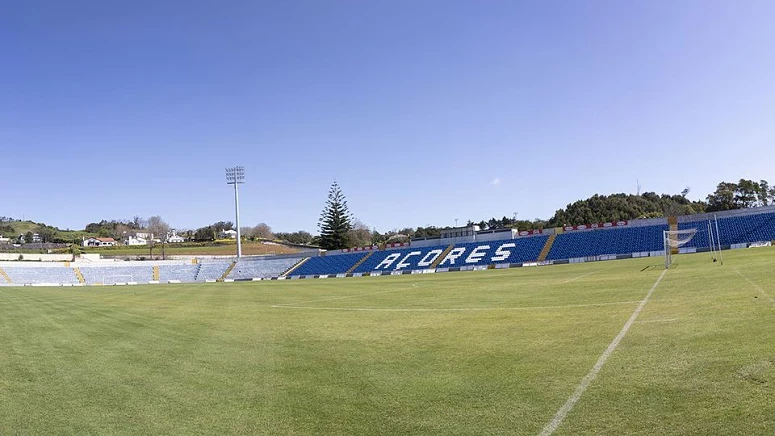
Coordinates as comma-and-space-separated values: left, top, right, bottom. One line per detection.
0, 179, 775, 249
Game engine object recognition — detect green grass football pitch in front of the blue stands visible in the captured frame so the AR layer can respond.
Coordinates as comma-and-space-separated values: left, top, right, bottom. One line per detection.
0, 248, 775, 435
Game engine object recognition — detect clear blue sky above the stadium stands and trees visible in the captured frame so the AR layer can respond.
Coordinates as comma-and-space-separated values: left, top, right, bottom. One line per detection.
0, 0, 775, 233
